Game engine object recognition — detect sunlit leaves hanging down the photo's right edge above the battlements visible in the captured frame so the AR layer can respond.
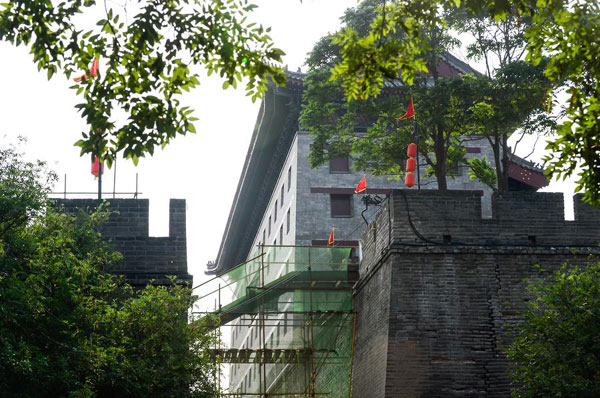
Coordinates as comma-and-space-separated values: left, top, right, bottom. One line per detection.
528, 1, 600, 206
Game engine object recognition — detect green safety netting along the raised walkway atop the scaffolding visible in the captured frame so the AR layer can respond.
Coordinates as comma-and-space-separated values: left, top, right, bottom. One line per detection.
194, 246, 351, 323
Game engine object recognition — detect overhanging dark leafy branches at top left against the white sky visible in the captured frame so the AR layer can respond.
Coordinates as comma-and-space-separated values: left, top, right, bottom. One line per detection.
0, 0, 284, 166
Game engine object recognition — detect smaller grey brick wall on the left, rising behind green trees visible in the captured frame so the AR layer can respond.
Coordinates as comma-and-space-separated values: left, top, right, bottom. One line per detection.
55, 199, 192, 287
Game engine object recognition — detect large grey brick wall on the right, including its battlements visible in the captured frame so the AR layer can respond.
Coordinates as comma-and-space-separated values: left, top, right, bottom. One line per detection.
353, 190, 600, 398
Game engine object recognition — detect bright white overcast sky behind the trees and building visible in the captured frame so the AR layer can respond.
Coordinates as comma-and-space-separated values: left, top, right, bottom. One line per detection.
0, 0, 572, 284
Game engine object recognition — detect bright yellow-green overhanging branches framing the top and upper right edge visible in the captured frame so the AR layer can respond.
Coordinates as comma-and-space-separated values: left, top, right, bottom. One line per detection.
333, 0, 600, 205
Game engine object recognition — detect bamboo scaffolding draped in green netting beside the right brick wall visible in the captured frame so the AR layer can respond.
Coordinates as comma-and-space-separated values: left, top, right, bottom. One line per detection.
194, 246, 357, 398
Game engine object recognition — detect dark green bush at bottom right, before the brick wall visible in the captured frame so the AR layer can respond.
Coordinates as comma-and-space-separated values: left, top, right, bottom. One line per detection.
508, 263, 600, 398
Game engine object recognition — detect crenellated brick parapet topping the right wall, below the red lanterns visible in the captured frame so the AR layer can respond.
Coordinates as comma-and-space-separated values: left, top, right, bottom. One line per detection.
362, 190, 600, 274
